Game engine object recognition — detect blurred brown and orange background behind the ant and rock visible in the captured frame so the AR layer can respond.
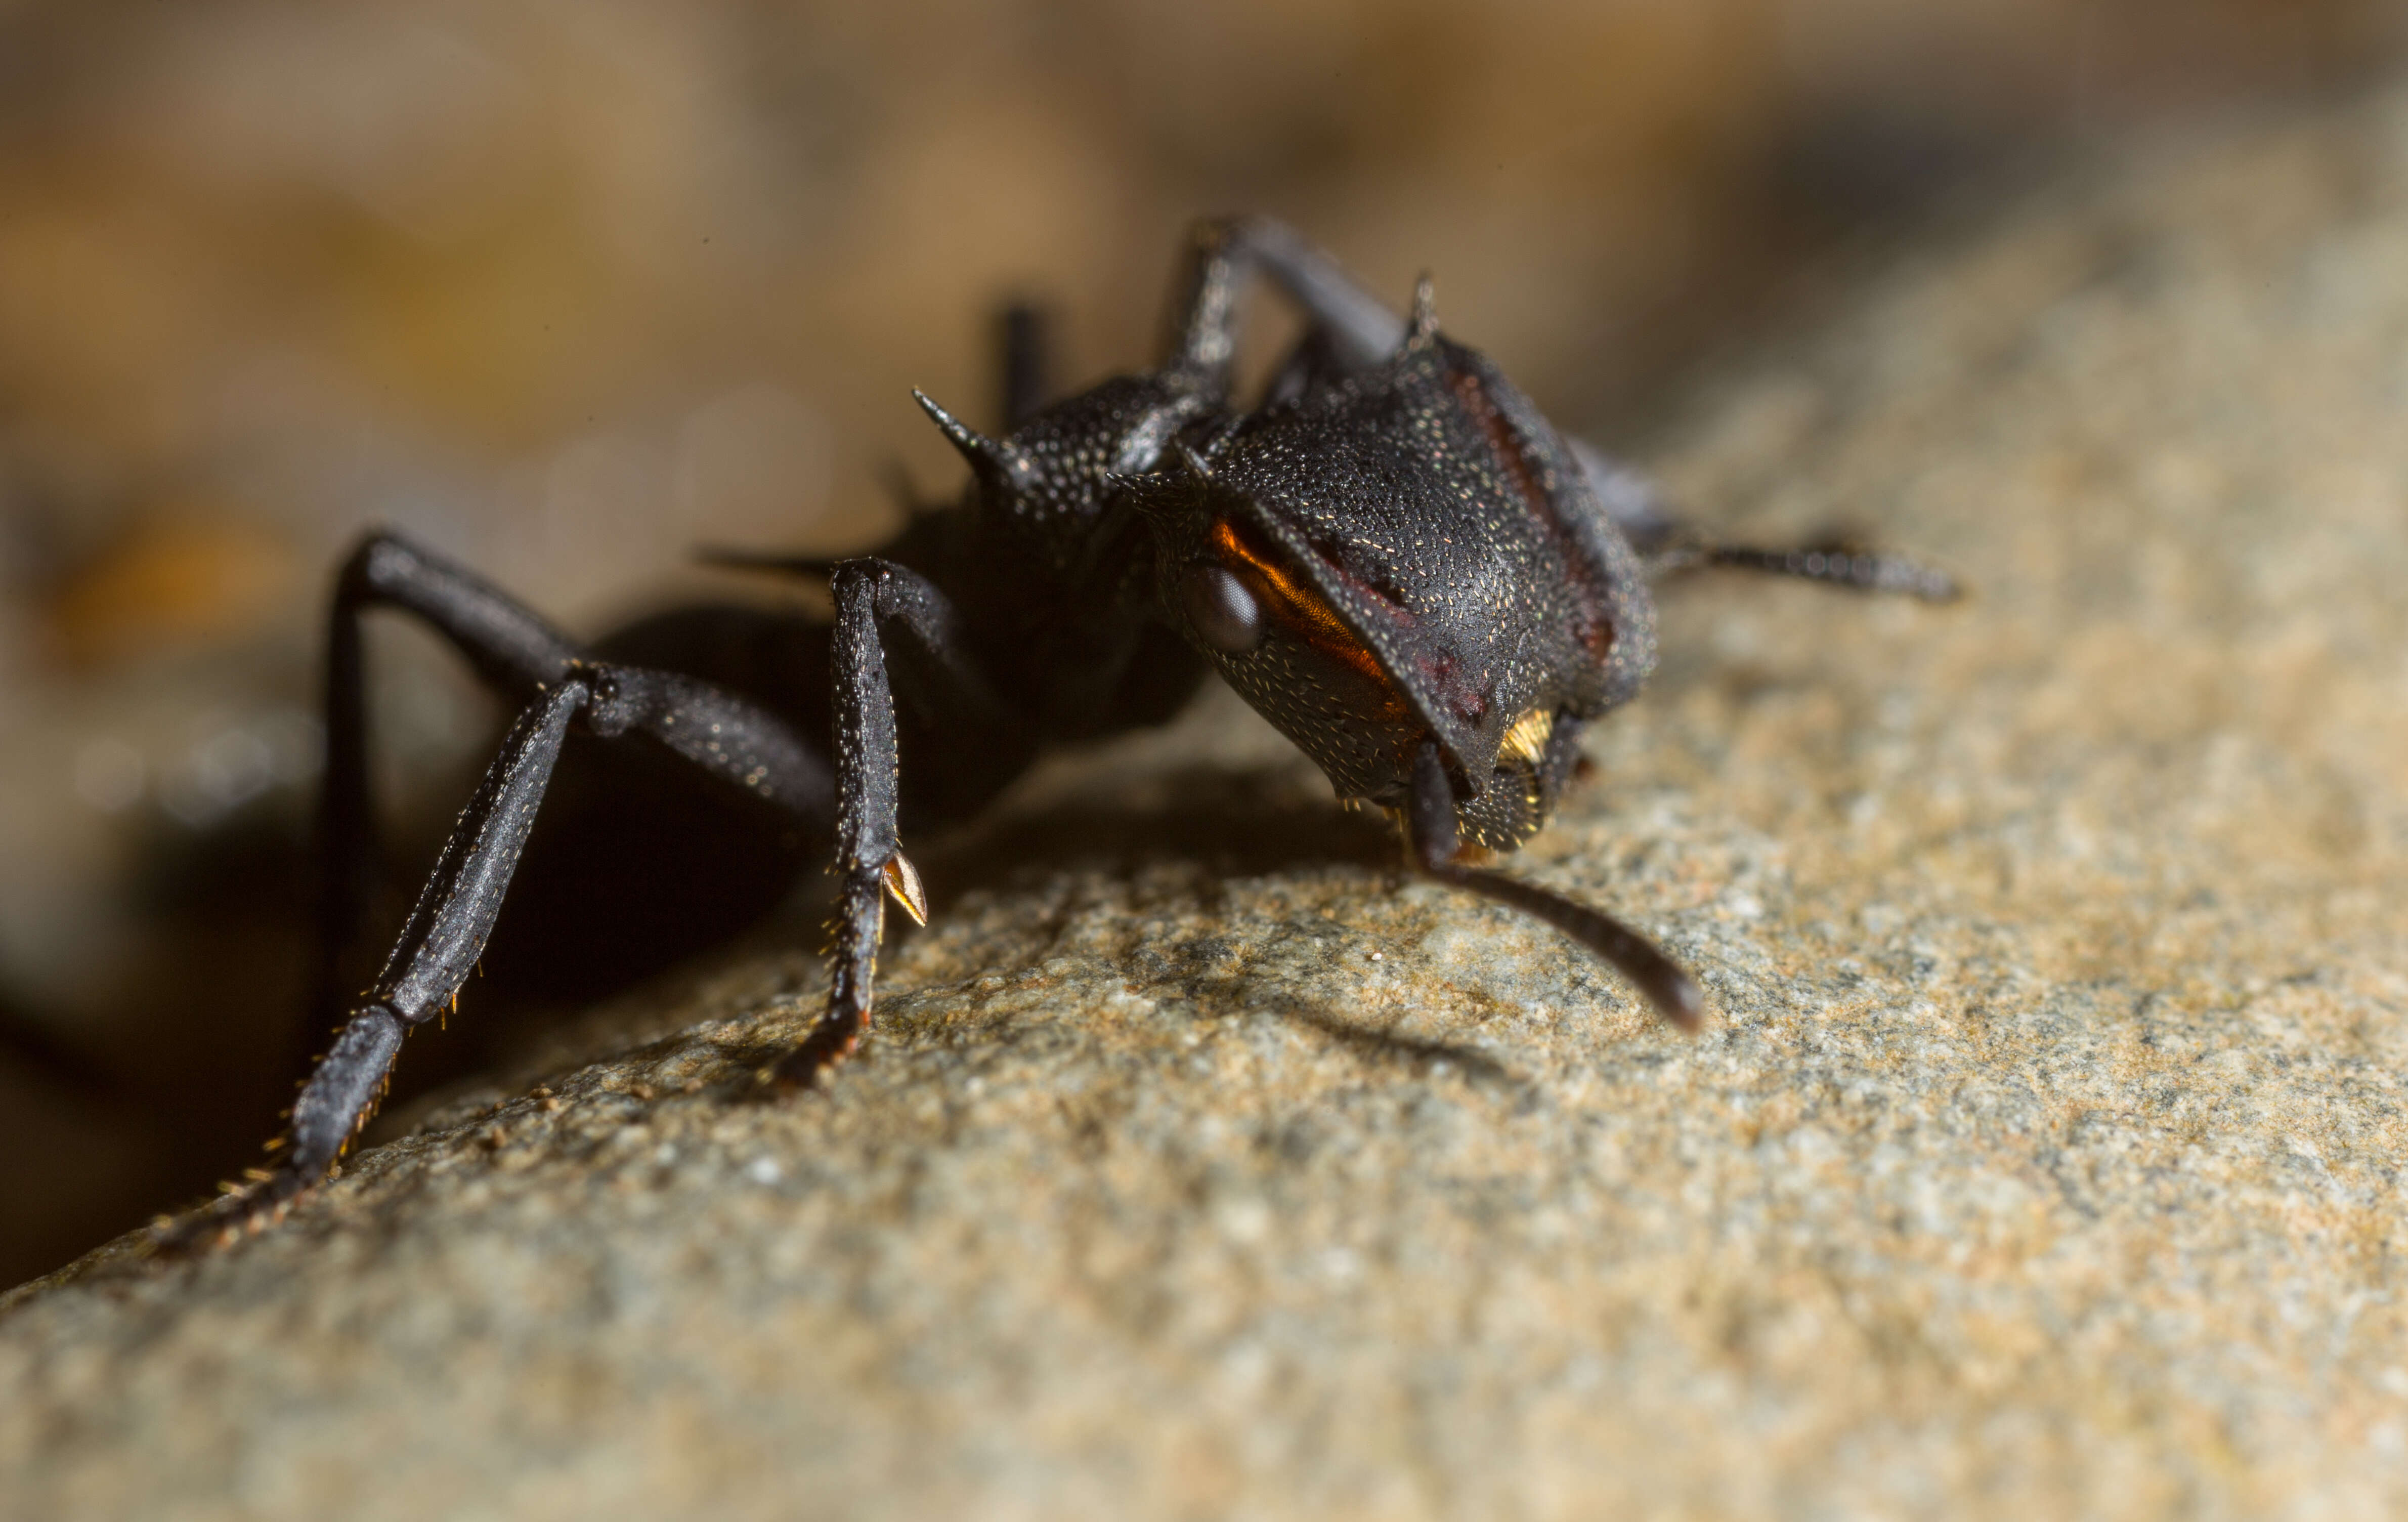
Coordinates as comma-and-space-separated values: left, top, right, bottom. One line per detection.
0, 0, 2408, 1286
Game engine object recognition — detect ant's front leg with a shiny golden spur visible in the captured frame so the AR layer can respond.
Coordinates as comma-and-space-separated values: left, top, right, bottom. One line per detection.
770, 556, 1033, 1086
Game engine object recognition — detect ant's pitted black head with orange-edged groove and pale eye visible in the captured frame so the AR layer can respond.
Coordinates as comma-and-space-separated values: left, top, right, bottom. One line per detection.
1125, 315, 1654, 848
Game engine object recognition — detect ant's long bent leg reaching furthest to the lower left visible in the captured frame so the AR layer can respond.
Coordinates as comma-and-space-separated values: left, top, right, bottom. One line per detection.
156, 662, 831, 1250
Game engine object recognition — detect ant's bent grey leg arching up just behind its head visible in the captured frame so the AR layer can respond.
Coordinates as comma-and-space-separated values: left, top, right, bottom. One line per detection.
1163, 217, 1404, 388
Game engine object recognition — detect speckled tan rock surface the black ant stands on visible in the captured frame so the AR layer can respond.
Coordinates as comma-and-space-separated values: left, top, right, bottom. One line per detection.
0, 96, 2408, 1517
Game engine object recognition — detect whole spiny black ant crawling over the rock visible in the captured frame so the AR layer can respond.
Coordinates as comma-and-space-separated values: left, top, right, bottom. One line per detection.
164, 219, 1953, 1245
